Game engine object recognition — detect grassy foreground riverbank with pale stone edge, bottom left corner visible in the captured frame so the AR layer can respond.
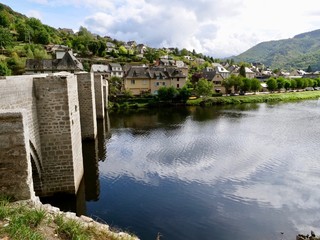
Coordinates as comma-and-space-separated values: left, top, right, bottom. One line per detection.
0, 199, 139, 240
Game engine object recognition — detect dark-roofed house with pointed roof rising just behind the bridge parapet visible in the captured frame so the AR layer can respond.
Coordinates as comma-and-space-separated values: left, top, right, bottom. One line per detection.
25, 51, 84, 75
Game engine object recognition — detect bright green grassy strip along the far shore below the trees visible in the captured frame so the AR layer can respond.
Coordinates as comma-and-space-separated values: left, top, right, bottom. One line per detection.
187, 91, 320, 106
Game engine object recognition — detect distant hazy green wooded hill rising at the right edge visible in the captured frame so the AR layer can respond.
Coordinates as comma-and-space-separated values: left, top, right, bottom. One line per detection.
234, 30, 320, 71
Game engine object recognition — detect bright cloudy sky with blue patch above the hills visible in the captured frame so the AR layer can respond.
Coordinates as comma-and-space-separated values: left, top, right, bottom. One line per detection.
1, 0, 320, 58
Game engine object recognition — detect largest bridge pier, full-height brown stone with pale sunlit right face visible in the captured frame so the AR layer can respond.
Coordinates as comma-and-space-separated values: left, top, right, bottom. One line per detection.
34, 75, 83, 196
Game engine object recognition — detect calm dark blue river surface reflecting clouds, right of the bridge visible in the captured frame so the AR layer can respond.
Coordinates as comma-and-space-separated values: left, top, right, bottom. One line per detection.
86, 101, 320, 240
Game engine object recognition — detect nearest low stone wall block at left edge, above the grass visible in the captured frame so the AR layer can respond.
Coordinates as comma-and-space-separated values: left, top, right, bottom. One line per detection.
0, 110, 35, 199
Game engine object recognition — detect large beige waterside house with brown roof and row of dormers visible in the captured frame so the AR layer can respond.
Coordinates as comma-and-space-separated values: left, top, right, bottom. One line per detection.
124, 66, 187, 95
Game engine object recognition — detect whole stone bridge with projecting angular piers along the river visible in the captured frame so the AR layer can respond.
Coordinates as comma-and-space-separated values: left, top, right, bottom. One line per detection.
0, 73, 108, 200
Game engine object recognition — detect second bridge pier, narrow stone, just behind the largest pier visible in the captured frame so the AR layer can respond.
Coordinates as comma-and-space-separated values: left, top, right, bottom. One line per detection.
76, 73, 97, 139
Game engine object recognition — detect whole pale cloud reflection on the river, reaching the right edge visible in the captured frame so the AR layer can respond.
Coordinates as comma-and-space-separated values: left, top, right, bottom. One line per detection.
100, 104, 320, 232
